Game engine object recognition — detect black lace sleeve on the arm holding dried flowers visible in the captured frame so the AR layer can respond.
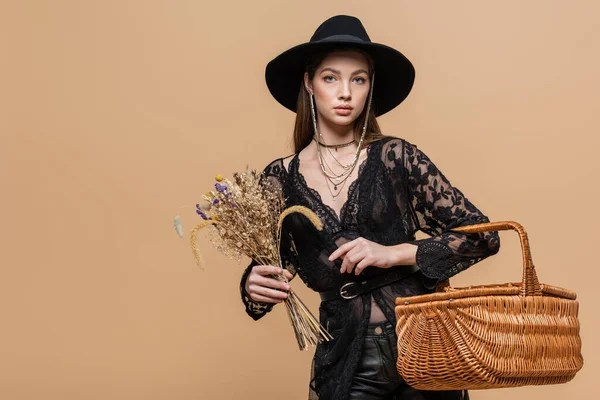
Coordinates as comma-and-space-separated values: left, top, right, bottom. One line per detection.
240, 159, 296, 320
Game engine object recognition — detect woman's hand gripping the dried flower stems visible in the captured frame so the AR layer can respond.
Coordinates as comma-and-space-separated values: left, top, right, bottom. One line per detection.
244, 265, 292, 304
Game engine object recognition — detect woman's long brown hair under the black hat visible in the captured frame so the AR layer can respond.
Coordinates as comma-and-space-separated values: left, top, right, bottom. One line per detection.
294, 46, 383, 153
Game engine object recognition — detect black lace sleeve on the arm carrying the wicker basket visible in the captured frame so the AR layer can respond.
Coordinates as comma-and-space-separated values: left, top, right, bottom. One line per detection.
386, 141, 500, 289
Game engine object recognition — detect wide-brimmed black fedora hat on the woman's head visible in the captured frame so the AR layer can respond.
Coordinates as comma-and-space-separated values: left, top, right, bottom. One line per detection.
265, 15, 415, 116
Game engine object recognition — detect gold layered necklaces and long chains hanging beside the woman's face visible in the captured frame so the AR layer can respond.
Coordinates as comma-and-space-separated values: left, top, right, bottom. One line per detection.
310, 74, 375, 200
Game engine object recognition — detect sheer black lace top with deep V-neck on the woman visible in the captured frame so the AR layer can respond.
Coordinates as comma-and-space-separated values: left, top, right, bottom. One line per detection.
241, 137, 500, 400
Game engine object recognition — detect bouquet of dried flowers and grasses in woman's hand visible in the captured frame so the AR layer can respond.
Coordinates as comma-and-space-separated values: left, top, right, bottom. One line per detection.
190, 170, 332, 350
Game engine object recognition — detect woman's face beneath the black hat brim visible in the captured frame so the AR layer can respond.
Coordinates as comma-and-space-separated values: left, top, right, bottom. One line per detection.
304, 51, 370, 125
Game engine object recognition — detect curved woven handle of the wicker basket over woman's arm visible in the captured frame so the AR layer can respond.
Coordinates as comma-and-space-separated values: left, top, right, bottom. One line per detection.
451, 221, 542, 296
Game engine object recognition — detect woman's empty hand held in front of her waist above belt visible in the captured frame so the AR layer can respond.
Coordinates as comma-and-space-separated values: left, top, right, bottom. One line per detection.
329, 237, 417, 275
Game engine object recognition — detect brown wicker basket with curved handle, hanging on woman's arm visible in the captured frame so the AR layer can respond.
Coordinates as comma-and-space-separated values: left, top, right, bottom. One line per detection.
395, 221, 583, 390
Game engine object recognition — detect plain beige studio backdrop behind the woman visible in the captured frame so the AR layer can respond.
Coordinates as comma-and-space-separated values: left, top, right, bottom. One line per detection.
0, 0, 600, 400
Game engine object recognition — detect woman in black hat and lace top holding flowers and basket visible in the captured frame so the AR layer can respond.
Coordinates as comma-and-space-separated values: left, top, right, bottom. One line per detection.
241, 15, 500, 400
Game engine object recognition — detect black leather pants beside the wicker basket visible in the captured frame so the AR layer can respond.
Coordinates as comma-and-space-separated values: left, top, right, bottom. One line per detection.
349, 321, 469, 400
